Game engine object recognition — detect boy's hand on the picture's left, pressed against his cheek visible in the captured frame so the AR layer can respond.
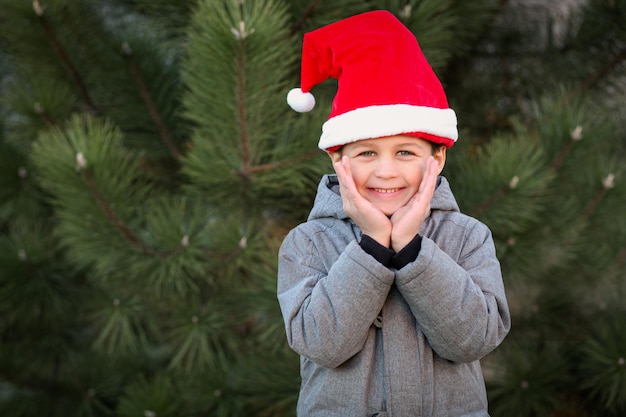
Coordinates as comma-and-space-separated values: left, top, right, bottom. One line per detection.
333, 155, 391, 248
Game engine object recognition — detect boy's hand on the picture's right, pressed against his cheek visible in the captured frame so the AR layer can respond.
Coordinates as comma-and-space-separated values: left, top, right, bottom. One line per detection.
391, 156, 438, 252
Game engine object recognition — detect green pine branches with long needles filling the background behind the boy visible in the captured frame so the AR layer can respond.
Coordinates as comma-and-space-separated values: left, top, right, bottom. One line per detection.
0, 0, 626, 417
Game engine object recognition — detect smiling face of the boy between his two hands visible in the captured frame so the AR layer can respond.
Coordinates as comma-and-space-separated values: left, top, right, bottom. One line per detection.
330, 135, 446, 216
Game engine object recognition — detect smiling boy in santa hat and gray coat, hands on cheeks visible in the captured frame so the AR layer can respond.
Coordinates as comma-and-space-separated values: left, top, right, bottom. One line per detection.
278, 11, 510, 417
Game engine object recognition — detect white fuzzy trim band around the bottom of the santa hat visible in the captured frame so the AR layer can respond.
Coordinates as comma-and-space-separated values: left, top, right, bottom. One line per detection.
318, 104, 458, 150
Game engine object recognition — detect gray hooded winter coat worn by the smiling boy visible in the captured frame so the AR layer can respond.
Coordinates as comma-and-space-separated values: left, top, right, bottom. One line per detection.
278, 175, 510, 417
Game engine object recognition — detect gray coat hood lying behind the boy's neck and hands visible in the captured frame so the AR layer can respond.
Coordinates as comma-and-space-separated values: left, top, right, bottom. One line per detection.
308, 174, 460, 220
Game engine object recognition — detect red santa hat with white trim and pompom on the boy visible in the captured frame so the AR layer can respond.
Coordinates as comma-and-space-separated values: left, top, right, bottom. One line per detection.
287, 10, 458, 151
